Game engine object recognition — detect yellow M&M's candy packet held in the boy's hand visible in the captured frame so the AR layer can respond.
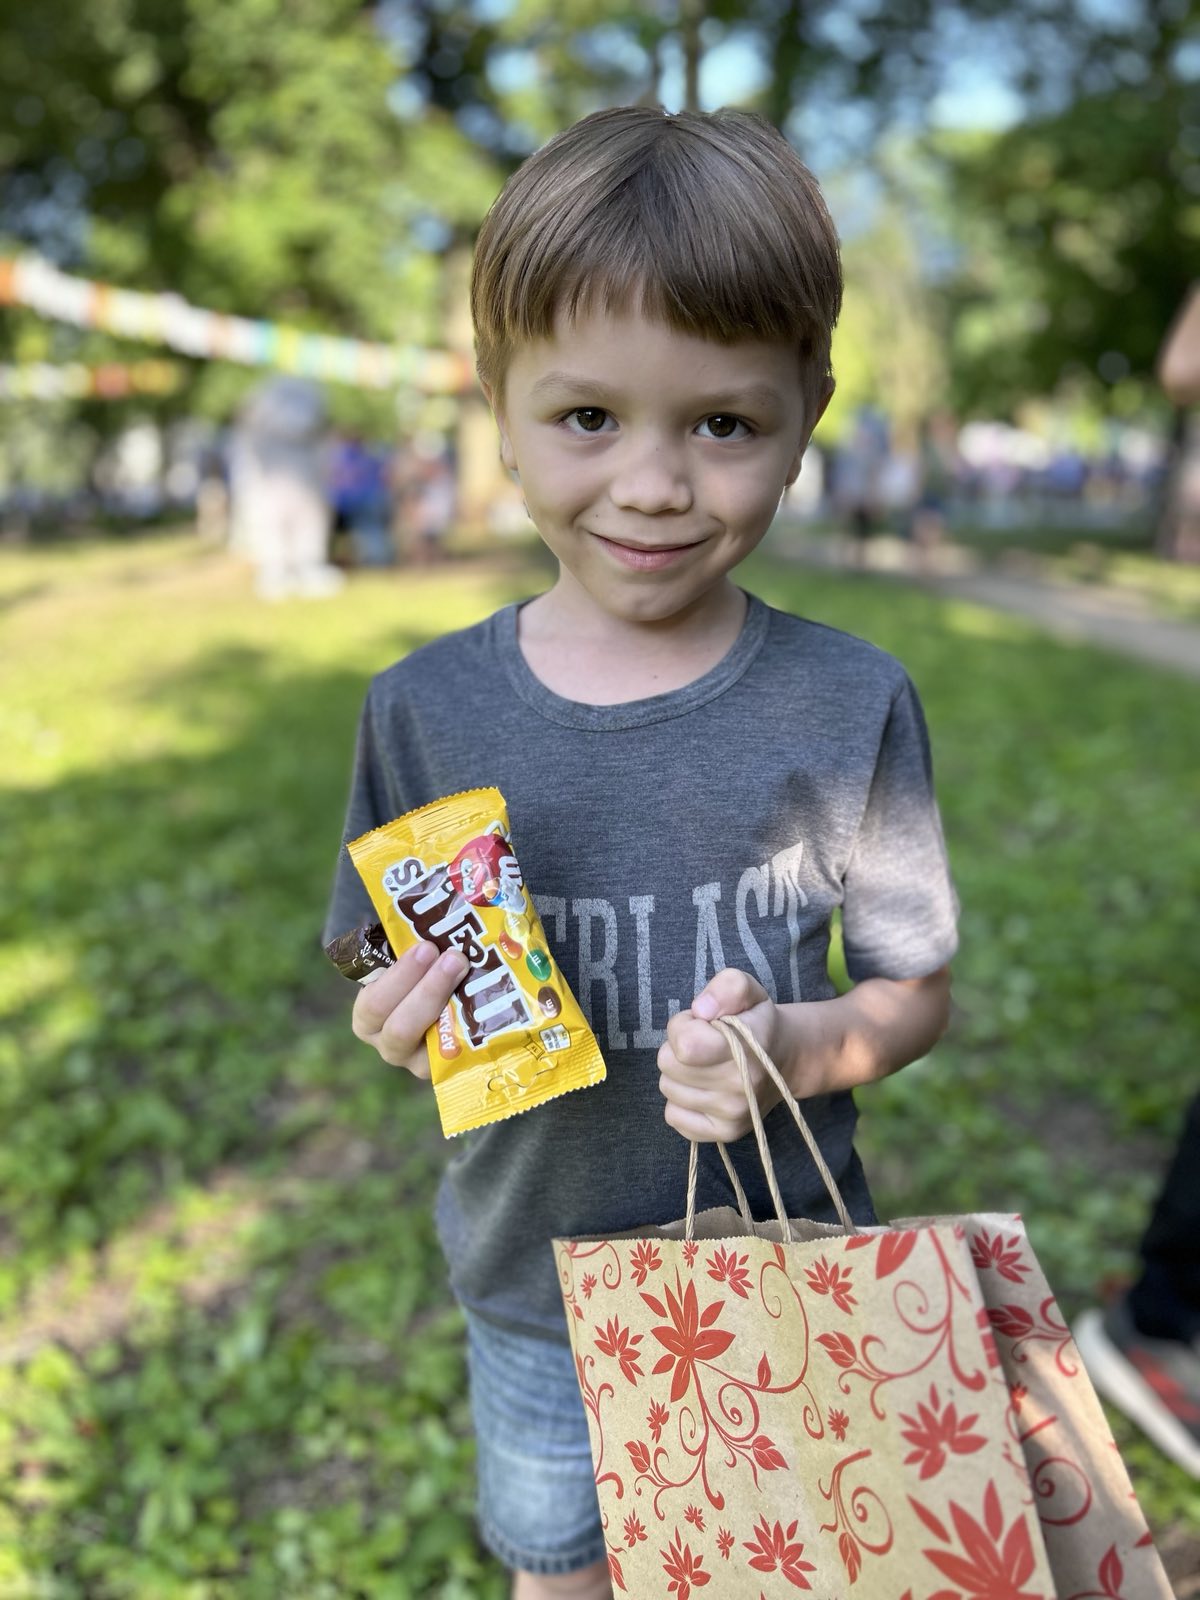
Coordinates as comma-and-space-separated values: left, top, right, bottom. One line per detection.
347, 789, 605, 1136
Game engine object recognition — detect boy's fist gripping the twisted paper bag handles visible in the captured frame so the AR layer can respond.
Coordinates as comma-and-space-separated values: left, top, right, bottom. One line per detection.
658, 966, 779, 1144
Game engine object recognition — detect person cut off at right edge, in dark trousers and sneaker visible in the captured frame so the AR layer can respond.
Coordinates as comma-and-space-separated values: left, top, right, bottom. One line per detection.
1075, 285, 1200, 1478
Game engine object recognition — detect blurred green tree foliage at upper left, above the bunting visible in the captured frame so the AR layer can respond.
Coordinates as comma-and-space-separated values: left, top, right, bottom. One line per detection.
0, 0, 499, 428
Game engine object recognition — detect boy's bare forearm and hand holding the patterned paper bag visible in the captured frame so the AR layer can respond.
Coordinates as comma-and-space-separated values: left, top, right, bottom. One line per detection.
658, 966, 950, 1144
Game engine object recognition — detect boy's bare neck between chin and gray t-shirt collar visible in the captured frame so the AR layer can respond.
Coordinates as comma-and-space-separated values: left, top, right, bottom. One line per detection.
517, 573, 746, 706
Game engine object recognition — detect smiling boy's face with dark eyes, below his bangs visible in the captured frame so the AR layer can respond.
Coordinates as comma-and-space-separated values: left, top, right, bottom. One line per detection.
490, 302, 816, 622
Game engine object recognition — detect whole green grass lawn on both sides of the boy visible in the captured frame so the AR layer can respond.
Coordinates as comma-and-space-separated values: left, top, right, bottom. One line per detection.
0, 536, 1200, 1600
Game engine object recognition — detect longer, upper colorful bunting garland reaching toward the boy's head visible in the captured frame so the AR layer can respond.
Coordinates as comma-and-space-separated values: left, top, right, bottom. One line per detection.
0, 254, 472, 394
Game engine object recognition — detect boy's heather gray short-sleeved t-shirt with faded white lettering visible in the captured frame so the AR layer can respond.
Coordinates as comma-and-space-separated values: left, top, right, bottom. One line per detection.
325, 597, 957, 1341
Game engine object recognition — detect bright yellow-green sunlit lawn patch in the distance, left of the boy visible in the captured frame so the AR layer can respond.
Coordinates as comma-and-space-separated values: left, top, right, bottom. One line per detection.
0, 539, 539, 792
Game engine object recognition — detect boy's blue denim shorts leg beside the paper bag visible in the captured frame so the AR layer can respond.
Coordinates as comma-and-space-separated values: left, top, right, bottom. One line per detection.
466, 1312, 606, 1576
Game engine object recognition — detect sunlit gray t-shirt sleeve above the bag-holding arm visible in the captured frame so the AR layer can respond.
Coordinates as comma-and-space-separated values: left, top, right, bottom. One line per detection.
842, 677, 958, 982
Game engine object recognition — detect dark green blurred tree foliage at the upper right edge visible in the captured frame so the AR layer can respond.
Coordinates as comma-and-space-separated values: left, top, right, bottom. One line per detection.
939, 82, 1200, 406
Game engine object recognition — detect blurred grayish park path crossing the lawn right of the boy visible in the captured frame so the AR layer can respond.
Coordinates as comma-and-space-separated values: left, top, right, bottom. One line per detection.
771, 530, 1200, 678
